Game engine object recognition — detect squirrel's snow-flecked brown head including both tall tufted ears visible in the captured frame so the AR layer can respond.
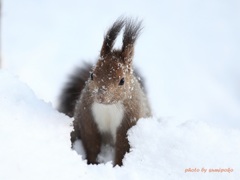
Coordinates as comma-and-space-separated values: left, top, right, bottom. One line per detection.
89, 18, 142, 104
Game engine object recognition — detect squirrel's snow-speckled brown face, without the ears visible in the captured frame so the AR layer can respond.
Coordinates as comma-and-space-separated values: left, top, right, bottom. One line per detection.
89, 52, 132, 104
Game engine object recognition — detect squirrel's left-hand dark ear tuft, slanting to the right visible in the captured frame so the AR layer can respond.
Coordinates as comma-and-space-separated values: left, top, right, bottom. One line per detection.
100, 17, 124, 57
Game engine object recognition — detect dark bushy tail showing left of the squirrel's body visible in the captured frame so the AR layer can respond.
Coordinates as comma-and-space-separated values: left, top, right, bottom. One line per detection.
58, 62, 92, 117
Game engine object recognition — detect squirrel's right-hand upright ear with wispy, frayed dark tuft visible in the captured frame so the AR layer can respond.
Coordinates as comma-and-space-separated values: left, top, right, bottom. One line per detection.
122, 19, 142, 62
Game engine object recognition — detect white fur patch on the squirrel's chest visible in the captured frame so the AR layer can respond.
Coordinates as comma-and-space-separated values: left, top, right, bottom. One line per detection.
92, 102, 124, 141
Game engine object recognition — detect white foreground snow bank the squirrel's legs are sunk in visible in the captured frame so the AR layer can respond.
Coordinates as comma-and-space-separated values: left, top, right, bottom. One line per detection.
0, 71, 240, 180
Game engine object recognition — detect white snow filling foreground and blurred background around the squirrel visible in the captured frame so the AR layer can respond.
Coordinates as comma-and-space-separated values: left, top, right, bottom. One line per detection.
0, 0, 240, 180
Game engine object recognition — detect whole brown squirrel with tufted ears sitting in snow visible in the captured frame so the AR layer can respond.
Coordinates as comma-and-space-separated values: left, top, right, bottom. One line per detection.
59, 18, 151, 166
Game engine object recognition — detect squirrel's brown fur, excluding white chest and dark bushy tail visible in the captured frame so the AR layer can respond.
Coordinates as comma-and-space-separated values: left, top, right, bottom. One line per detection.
62, 18, 151, 165
